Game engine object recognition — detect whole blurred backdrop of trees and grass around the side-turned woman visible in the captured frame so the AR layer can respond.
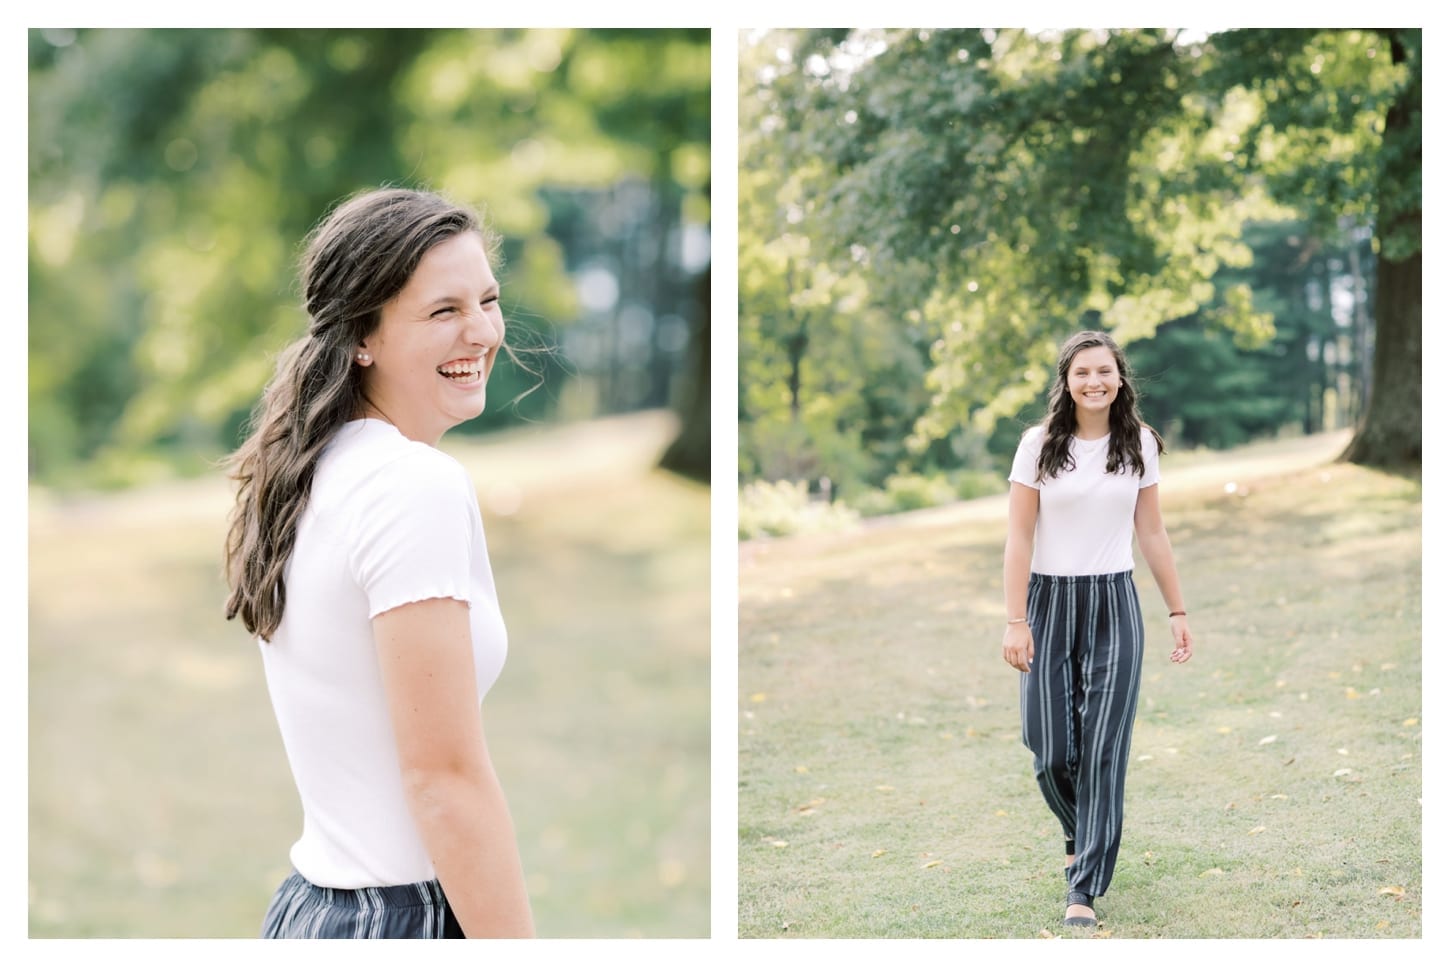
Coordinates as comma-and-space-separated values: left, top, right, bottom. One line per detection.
26, 29, 711, 937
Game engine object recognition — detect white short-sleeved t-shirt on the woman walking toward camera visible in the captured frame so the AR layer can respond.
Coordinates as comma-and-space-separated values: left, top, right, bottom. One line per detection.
1008, 426, 1159, 574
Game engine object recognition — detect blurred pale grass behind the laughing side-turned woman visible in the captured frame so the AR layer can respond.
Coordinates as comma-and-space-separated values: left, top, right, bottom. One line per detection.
29, 415, 709, 937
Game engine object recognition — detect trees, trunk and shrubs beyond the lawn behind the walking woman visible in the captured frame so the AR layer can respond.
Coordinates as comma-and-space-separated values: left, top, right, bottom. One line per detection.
738, 29, 1421, 535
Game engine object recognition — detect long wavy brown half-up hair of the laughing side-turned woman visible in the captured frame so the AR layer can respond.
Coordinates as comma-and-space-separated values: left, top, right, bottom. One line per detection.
226, 188, 497, 639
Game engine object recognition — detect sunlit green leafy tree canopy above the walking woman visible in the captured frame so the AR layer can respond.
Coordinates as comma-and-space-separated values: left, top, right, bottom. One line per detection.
741, 29, 1420, 498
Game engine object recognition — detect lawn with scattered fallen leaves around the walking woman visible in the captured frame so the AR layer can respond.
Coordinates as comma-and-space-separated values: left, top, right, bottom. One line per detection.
738, 439, 1424, 938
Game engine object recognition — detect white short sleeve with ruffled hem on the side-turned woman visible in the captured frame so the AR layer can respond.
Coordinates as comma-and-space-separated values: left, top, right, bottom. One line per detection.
349, 451, 474, 619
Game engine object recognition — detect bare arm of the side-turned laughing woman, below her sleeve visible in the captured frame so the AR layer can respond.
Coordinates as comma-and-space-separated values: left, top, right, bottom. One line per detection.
373, 597, 534, 937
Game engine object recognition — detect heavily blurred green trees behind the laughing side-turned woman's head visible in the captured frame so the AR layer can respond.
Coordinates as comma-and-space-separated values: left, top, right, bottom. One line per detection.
29, 29, 709, 484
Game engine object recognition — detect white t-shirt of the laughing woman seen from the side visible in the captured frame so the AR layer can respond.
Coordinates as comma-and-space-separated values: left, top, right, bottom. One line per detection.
258, 419, 508, 889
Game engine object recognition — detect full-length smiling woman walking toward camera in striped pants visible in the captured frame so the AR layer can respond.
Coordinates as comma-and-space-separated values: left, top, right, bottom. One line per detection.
1002, 332, 1193, 926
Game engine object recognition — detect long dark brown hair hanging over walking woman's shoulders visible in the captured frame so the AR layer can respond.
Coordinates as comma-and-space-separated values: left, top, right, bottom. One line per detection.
1037, 329, 1163, 483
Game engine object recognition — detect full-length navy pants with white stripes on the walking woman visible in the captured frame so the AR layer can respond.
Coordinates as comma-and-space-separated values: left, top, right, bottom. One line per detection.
1022, 571, 1143, 896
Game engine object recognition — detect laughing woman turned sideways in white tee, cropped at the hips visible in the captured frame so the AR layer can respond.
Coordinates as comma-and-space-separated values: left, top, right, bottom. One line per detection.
226, 190, 534, 938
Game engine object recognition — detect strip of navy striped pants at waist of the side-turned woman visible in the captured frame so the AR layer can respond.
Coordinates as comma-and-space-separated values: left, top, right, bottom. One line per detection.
262, 870, 463, 939
